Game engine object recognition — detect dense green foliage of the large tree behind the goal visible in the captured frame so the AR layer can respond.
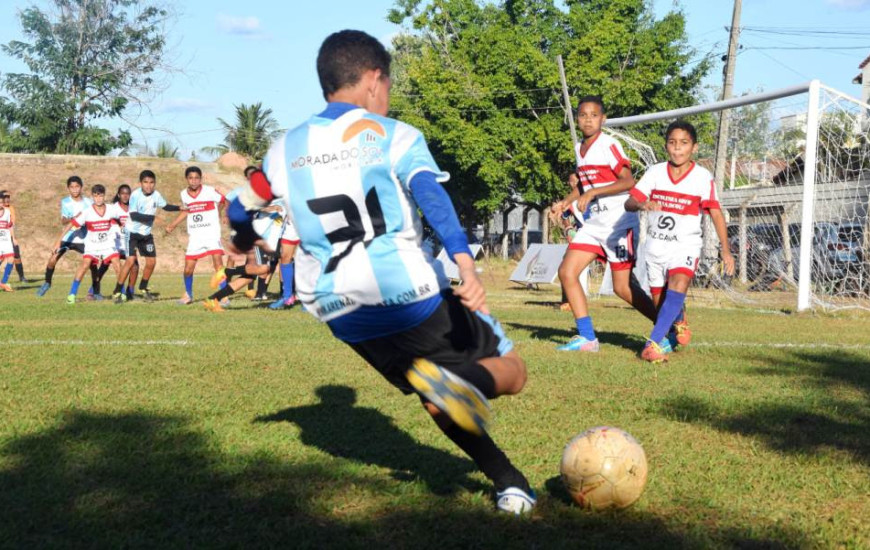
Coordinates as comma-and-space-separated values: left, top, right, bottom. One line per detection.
389, 0, 709, 226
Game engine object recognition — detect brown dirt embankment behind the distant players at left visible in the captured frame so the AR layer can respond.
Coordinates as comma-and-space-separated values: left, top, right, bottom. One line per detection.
0, 154, 244, 278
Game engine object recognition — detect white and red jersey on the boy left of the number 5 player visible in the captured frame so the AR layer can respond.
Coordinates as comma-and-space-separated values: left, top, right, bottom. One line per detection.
577, 133, 637, 227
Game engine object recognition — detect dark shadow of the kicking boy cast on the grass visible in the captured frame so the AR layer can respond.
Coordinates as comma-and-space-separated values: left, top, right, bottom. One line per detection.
255, 386, 485, 494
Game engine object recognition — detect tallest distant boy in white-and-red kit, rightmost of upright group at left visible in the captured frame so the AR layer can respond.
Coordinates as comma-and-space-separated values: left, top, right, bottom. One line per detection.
166, 166, 226, 305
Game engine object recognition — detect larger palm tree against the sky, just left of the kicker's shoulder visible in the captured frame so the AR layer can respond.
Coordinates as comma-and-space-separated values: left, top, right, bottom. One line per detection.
202, 102, 281, 160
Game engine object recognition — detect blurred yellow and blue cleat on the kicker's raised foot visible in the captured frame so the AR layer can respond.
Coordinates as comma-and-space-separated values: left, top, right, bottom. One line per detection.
405, 358, 492, 435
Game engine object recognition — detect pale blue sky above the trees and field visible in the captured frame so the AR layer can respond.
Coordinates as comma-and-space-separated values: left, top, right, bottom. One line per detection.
0, 0, 870, 158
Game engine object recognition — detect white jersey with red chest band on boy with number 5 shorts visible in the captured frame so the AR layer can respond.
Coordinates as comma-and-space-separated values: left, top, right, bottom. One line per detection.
631, 162, 719, 258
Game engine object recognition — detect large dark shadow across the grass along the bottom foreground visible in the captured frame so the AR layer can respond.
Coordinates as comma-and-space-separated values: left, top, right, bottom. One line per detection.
0, 410, 807, 550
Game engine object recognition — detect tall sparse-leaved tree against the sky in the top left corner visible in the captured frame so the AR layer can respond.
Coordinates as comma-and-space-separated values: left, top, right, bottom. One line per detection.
0, 0, 170, 154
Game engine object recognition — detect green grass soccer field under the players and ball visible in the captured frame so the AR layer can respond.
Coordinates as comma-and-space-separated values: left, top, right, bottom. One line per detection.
0, 273, 870, 549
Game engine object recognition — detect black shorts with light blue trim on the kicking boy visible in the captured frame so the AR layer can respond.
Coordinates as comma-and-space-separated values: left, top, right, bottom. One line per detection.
348, 292, 513, 394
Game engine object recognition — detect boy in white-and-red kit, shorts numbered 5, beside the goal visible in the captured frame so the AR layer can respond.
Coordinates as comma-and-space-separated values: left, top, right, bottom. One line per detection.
625, 120, 734, 363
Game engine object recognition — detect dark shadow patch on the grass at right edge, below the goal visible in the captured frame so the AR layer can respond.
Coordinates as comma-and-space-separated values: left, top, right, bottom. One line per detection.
660, 352, 870, 464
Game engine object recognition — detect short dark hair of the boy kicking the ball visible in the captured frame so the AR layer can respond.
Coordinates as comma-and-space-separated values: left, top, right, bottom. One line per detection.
317, 30, 392, 98
